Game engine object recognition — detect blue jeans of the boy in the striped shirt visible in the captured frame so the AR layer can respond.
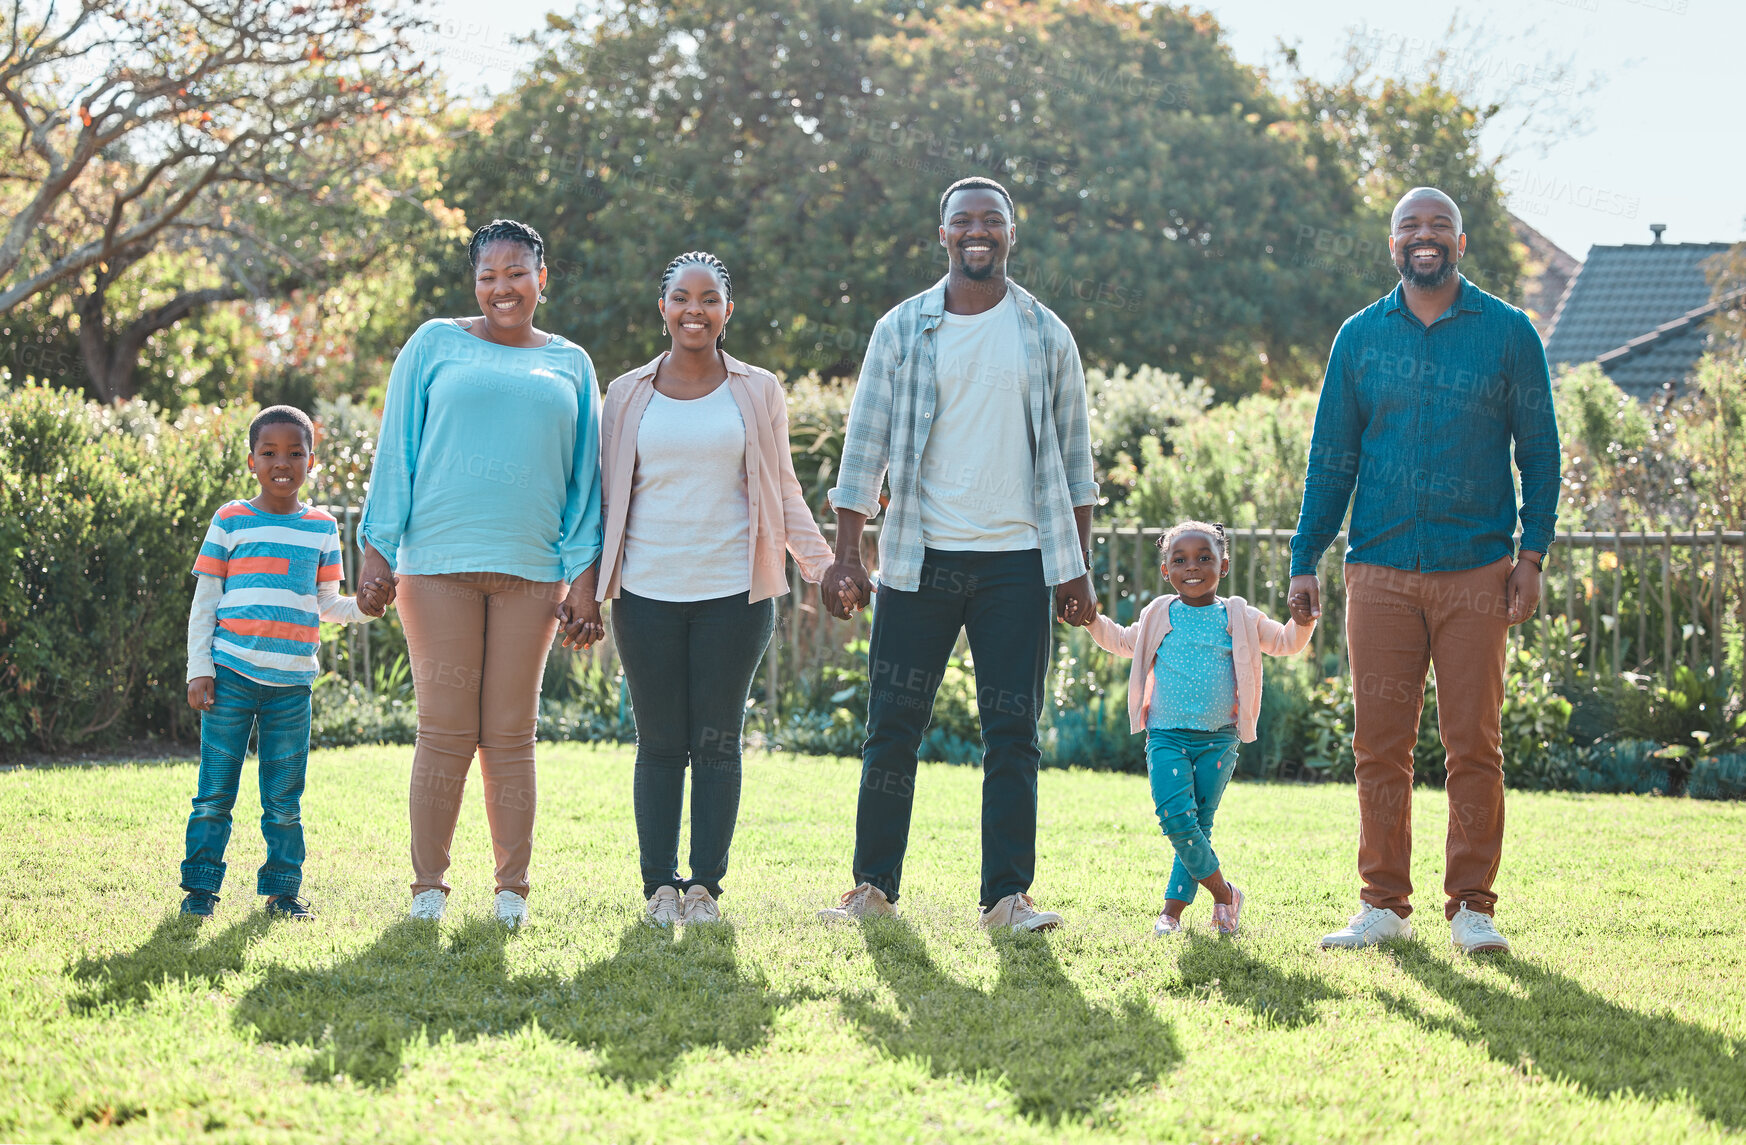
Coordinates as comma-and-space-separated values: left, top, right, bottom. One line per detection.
182, 665, 309, 895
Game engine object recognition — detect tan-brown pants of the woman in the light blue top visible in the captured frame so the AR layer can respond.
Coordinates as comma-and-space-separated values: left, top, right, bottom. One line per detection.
398, 573, 564, 895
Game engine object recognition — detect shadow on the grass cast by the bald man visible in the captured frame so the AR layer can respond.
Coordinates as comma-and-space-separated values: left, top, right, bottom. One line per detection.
1379, 946, 1746, 1129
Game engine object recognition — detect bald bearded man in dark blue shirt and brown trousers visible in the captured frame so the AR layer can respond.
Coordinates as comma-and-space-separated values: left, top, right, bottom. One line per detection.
1290, 187, 1559, 953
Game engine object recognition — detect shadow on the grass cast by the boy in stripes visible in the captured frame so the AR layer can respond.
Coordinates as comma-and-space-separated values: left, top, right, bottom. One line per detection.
66, 911, 272, 1014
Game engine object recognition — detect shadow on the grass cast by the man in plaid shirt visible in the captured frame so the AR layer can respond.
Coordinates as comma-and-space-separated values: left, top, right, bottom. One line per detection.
843, 920, 1182, 1124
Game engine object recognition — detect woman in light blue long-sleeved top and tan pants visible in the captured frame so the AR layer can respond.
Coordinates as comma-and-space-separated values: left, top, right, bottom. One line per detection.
361, 218, 604, 927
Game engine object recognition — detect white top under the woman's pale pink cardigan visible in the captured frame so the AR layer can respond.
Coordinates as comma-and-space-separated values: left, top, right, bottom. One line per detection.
620, 382, 753, 600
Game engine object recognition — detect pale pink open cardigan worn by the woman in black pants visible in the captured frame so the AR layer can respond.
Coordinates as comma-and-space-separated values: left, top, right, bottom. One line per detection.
595, 353, 833, 604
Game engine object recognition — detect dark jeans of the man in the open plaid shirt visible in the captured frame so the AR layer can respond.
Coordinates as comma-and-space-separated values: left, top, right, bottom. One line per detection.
854, 548, 1053, 906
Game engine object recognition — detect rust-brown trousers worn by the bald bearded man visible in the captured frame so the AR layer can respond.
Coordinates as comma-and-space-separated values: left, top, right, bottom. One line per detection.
1346, 557, 1512, 918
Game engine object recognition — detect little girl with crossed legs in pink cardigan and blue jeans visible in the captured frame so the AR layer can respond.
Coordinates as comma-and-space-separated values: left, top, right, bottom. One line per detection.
1068, 520, 1315, 937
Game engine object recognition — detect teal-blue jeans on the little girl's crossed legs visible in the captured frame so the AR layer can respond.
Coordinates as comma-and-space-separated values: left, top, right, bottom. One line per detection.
1145, 728, 1236, 902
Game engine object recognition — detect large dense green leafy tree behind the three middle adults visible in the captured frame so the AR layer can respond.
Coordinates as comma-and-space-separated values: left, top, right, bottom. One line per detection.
423, 0, 1358, 393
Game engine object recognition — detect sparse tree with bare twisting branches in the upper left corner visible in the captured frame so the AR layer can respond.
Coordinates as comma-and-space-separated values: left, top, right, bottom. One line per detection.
0, 0, 443, 400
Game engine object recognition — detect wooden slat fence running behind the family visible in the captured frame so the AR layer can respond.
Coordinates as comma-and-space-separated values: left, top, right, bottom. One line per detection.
317, 506, 1746, 715
